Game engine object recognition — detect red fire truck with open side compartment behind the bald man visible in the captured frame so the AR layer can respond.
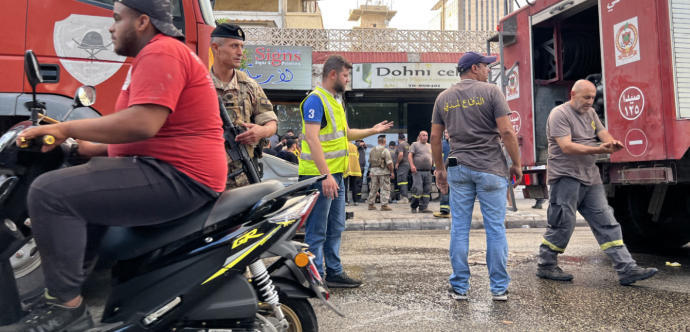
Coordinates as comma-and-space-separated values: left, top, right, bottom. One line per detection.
487, 0, 690, 247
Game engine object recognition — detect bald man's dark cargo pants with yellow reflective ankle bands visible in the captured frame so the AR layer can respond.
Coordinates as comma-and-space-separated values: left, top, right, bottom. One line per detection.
539, 177, 637, 274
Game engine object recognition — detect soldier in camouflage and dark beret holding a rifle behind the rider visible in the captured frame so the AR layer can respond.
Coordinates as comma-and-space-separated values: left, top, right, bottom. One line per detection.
211, 23, 278, 190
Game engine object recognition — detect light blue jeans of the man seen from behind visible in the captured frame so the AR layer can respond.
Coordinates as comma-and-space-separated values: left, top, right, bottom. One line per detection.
448, 165, 510, 294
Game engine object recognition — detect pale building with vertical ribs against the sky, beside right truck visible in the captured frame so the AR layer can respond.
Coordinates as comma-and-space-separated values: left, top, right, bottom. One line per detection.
429, 0, 513, 31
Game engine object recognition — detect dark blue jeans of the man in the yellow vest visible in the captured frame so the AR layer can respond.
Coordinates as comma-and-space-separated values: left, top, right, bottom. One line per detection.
299, 173, 345, 276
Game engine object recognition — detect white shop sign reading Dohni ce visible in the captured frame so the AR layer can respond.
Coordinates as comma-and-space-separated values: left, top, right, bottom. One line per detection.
352, 63, 460, 89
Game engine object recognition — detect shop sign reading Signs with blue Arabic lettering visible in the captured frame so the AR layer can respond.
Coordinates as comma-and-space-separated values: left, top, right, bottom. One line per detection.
239, 45, 312, 90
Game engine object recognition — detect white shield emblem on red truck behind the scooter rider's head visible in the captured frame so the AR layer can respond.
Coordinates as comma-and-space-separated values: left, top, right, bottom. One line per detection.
53, 14, 127, 86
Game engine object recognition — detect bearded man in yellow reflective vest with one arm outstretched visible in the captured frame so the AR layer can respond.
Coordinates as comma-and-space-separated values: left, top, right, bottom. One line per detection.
299, 55, 393, 288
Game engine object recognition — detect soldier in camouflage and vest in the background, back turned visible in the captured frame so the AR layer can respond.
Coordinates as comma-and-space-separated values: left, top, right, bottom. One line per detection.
367, 135, 395, 211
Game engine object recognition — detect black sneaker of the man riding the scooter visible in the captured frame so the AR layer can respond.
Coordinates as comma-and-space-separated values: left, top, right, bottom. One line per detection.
0, 300, 94, 332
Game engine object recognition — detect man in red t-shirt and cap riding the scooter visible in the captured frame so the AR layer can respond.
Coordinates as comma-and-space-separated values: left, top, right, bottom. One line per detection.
5, 0, 227, 332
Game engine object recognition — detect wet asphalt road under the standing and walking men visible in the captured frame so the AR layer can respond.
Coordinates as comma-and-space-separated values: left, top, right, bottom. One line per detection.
313, 227, 690, 332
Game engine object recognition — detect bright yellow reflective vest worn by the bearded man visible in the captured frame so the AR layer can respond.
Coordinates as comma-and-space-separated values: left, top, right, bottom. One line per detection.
299, 87, 348, 175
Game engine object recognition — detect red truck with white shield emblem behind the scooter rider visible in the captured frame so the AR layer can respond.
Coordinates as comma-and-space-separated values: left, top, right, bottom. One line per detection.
0, 0, 215, 132
